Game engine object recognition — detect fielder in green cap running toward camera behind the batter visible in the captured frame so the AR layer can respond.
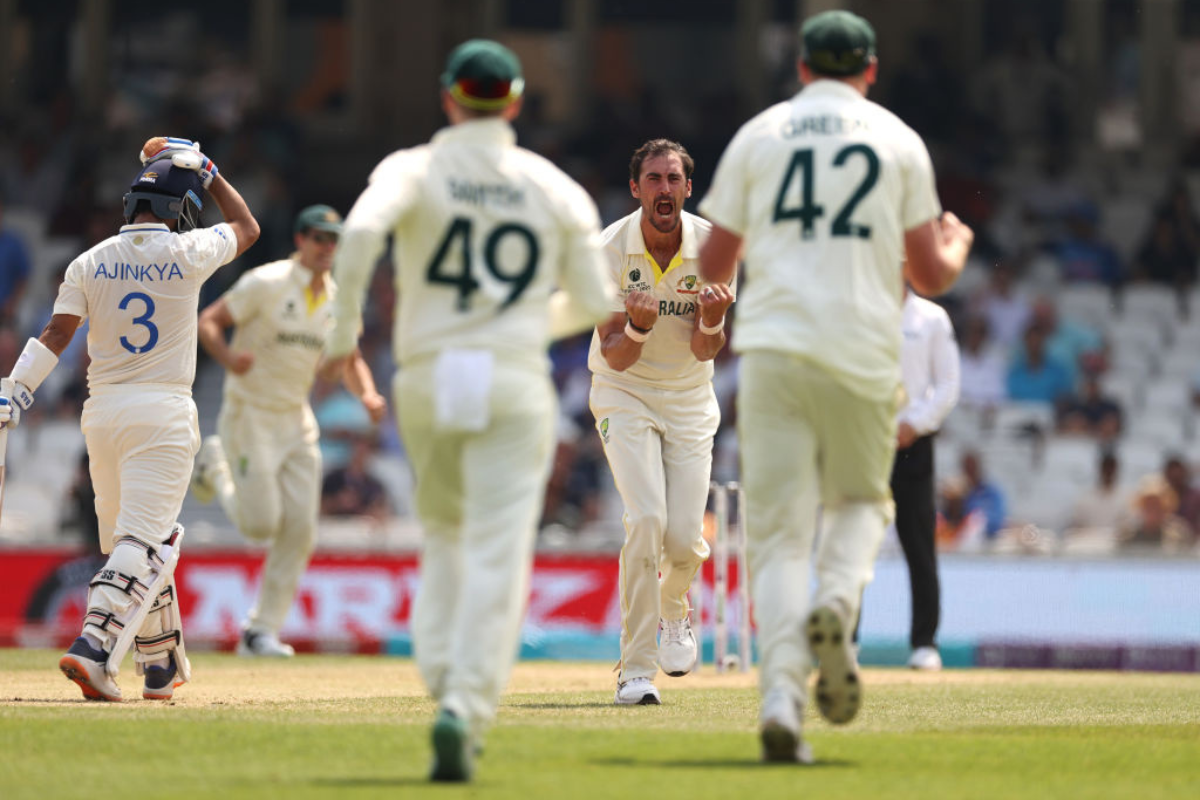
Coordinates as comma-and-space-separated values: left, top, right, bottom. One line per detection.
192, 205, 386, 657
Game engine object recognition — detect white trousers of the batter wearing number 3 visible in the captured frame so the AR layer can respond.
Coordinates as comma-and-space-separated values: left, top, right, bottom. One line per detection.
80, 384, 200, 649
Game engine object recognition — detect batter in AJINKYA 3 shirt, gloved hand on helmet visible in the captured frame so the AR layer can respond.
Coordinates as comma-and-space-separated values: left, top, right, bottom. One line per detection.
0, 137, 258, 700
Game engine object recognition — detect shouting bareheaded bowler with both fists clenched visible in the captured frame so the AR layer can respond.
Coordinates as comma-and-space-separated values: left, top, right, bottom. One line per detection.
588, 139, 733, 705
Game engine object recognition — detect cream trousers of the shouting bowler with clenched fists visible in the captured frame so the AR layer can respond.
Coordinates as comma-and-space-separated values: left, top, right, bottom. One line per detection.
590, 378, 721, 681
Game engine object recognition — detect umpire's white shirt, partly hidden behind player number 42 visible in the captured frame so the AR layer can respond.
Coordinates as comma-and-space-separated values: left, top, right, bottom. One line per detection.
896, 291, 959, 435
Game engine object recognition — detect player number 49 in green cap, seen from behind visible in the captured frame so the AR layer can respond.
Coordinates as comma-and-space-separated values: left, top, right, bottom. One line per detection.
325, 40, 613, 781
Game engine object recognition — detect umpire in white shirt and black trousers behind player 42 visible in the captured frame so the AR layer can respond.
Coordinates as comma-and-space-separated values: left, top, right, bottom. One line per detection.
892, 289, 959, 669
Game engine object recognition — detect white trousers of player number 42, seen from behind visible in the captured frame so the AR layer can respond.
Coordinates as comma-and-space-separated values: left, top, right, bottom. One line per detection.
738, 350, 896, 703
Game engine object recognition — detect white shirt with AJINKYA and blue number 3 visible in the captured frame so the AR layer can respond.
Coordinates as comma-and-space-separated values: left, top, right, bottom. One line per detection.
54, 222, 238, 392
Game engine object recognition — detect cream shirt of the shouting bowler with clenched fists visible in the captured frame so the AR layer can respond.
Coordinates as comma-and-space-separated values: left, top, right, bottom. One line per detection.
588, 209, 713, 389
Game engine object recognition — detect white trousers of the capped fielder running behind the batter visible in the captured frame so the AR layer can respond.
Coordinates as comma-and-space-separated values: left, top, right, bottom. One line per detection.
216, 398, 320, 634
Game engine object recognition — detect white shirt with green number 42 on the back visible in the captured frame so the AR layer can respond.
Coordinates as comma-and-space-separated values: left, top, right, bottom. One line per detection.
700, 80, 941, 398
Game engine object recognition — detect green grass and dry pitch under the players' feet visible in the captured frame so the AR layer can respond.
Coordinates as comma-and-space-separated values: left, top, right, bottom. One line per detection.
0, 650, 1200, 800
